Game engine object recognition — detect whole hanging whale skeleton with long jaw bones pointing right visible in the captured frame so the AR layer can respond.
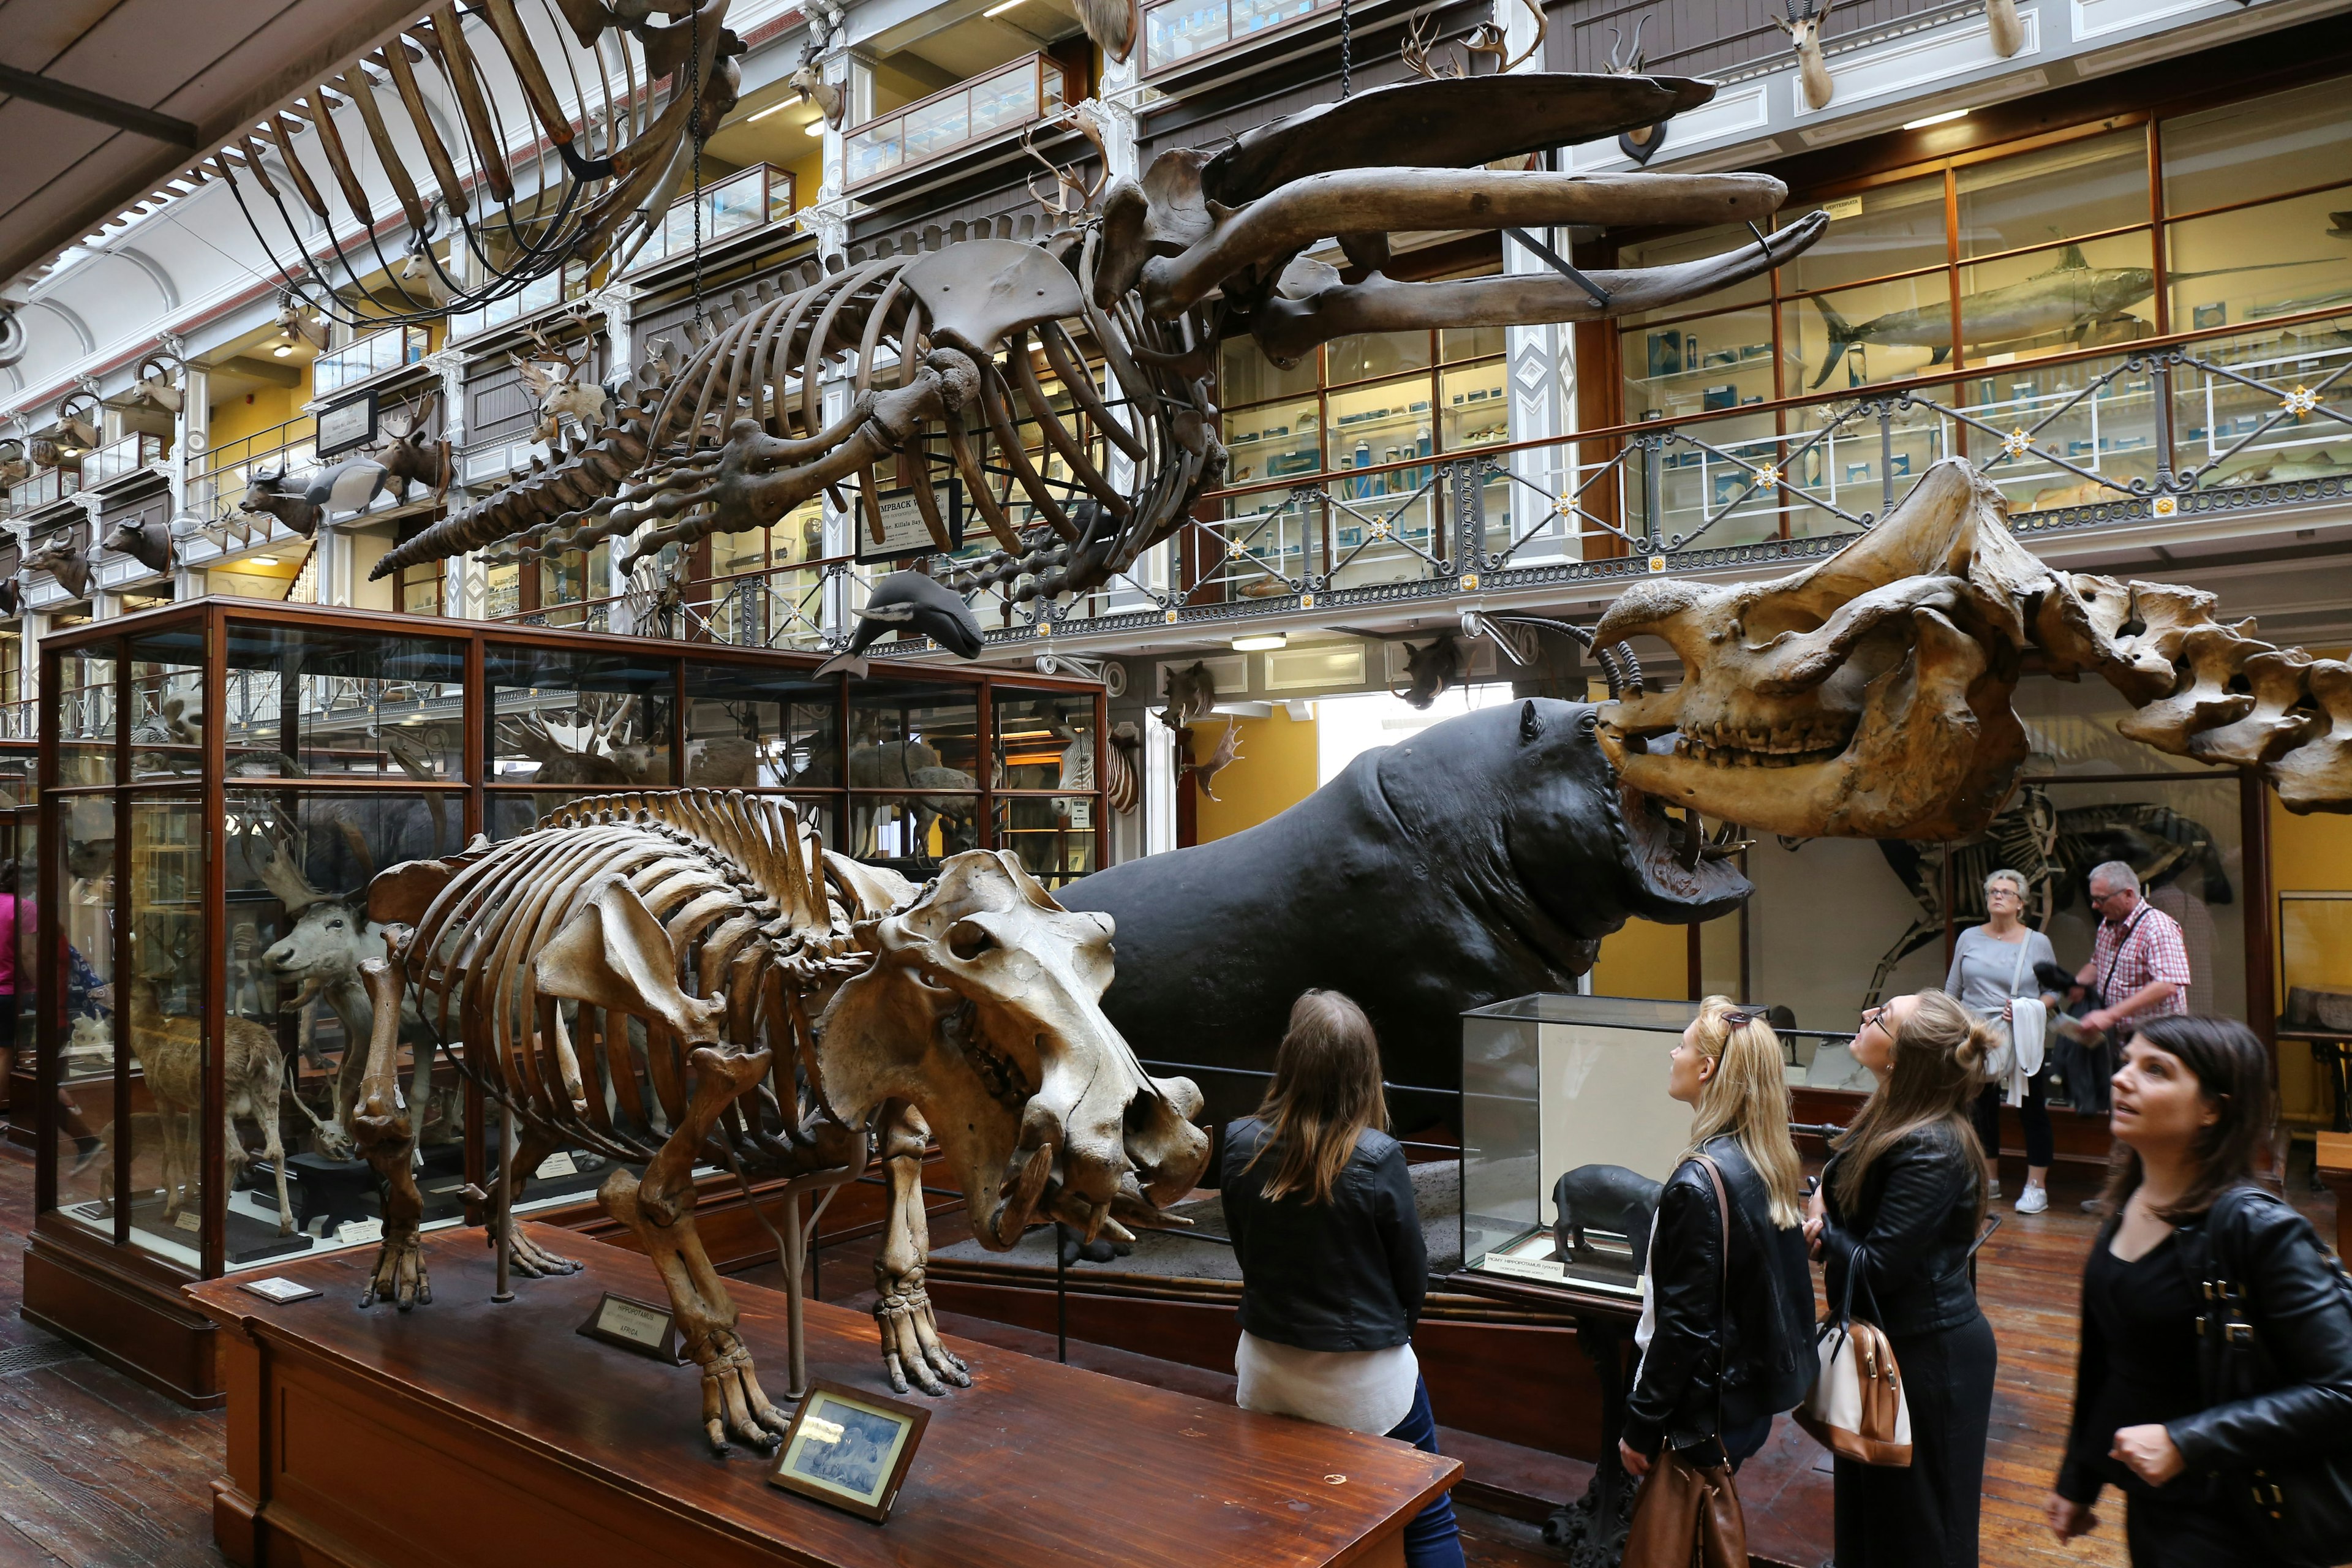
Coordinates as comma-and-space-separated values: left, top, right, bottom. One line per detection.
376, 73, 1828, 602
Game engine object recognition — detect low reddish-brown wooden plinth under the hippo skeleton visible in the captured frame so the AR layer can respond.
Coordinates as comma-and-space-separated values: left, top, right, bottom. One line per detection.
188, 1225, 1461, 1568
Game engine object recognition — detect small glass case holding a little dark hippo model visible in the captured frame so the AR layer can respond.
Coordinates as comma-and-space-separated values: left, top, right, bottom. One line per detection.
1461, 995, 1698, 1300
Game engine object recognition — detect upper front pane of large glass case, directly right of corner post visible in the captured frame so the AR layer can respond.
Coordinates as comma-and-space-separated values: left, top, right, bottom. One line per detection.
221, 620, 466, 783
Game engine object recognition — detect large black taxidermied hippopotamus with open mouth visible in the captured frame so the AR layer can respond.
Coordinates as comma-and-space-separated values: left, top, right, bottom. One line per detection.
1056, 698, 1747, 1119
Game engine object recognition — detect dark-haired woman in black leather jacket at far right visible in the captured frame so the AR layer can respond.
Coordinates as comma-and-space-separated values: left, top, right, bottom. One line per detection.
2046, 1013, 2352, 1568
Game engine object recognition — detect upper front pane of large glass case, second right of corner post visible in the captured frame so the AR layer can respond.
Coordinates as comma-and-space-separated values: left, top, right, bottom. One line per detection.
482, 642, 675, 790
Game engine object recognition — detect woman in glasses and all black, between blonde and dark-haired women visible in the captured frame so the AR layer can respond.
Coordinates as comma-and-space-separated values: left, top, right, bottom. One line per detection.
1806, 990, 1997, 1568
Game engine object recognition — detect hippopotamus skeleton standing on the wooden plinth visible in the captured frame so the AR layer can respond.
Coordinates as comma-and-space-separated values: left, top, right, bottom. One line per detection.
353, 790, 1209, 1453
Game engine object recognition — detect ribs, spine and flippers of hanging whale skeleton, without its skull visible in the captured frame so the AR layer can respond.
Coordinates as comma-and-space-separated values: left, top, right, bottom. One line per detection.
376, 233, 1226, 602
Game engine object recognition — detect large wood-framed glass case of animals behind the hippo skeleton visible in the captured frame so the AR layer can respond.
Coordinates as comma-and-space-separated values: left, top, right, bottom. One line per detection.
28, 600, 1106, 1389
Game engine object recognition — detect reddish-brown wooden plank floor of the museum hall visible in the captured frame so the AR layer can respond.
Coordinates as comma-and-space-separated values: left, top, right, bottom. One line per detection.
0, 1150, 2335, 1568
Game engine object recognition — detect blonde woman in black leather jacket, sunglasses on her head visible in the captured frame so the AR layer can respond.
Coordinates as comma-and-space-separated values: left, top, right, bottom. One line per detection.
1618, 997, 1814, 1476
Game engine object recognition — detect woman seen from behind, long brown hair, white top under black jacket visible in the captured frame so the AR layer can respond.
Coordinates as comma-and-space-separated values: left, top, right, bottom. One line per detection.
1223, 990, 1463, 1568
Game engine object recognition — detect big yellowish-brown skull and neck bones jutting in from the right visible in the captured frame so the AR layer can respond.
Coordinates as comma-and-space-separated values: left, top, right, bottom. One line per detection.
1595, 458, 2352, 839
